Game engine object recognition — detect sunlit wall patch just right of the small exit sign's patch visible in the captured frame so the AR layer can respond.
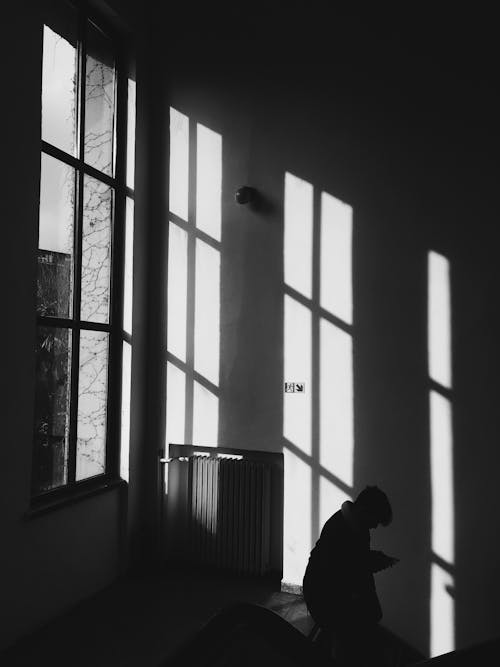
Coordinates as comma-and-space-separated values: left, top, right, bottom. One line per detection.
320, 320, 354, 486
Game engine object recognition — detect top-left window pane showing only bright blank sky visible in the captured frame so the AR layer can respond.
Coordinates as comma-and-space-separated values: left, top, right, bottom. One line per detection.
42, 26, 77, 155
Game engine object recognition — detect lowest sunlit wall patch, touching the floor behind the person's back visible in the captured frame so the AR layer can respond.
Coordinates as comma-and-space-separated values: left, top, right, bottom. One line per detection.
283, 449, 312, 584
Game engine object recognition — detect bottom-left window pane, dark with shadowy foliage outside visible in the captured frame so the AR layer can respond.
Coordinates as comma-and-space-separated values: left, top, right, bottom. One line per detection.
32, 327, 71, 493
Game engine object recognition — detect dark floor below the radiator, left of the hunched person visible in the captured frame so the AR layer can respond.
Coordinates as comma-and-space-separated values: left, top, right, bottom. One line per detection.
0, 570, 312, 667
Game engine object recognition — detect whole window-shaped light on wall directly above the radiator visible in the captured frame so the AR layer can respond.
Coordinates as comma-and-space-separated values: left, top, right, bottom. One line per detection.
165, 108, 222, 474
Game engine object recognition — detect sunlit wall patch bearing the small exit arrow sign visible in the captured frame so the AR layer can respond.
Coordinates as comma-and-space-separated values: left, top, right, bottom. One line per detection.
283, 295, 312, 454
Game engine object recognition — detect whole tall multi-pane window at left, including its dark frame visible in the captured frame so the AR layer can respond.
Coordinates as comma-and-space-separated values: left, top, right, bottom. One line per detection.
32, 2, 135, 498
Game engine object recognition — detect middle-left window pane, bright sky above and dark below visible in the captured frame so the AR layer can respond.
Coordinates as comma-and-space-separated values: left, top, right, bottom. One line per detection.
37, 153, 75, 317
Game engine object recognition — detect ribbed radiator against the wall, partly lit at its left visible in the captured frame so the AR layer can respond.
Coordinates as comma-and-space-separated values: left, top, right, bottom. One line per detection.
184, 455, 271, 575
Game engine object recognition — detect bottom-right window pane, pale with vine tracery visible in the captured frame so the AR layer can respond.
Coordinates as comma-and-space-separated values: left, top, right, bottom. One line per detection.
76, 331, 108, 480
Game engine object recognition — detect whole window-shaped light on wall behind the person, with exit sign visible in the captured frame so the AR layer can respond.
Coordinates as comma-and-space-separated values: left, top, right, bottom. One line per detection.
283, 172, 354, 587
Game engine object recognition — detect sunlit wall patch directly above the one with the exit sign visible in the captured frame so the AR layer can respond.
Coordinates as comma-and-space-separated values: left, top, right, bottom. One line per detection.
283, 172, 313, 298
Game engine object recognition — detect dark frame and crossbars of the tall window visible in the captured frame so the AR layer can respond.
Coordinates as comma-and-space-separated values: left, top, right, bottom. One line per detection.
30, 0, 134, 509
